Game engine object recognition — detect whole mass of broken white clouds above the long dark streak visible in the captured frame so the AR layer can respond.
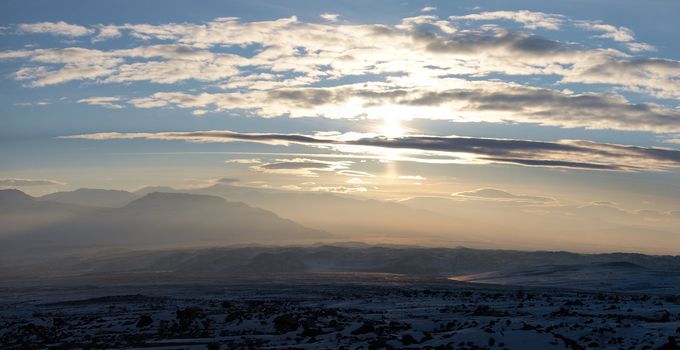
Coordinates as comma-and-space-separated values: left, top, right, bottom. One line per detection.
0, 11, 680, 133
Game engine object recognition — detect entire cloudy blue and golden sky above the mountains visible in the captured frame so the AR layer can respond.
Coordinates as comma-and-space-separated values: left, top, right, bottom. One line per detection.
0, 0, 680, 252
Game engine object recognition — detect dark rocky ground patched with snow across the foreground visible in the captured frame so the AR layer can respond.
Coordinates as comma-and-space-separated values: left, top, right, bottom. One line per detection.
0, 274, 680, 349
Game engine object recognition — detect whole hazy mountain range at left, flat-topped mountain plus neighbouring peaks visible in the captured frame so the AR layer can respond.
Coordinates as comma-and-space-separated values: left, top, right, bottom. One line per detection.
0, 190, 331, 259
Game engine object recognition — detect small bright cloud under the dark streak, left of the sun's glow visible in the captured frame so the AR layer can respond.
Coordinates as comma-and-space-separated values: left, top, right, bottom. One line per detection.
250, 158, 352, 177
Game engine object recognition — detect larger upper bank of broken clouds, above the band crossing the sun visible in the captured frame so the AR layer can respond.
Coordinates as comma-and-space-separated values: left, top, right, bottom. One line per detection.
0, 15, 680, 101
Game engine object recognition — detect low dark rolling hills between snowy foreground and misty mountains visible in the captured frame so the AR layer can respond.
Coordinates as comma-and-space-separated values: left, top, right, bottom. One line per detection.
7, 245, 680, 293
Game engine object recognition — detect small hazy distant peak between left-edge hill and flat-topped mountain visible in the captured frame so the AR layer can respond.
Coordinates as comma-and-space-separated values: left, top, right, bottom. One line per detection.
38, 188, 139, 208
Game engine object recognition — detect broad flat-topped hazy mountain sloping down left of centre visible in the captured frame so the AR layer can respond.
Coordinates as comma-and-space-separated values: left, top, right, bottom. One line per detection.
0, 193, 329, 255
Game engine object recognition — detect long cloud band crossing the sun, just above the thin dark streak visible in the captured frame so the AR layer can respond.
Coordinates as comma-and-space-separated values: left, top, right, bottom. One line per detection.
117, 83, 680, 133
